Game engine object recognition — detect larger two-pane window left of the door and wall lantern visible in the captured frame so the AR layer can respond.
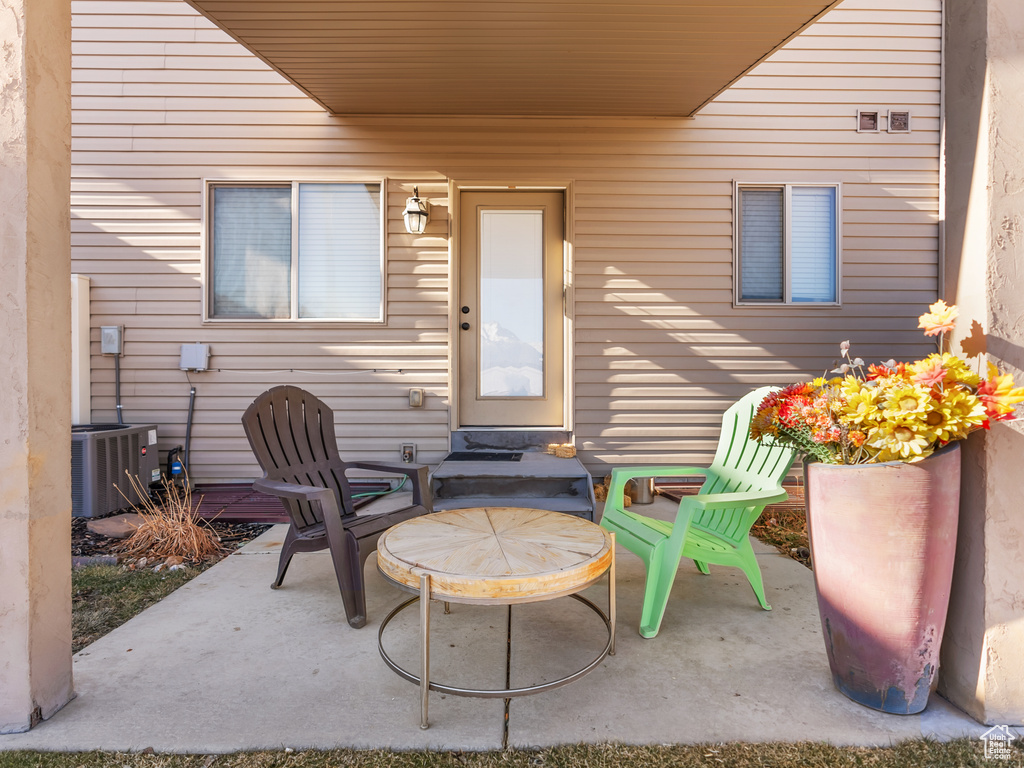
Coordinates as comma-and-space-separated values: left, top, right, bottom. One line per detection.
207, 182, 384, 323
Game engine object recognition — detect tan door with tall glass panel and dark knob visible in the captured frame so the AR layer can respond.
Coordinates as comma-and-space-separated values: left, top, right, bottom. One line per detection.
457, 191, 565, 427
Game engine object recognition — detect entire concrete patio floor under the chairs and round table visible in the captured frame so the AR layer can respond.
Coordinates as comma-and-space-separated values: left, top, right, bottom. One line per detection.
0, 499, 987, 754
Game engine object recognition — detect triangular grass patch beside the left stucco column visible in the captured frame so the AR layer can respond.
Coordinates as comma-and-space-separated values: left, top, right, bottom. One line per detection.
72, 563, 208, 651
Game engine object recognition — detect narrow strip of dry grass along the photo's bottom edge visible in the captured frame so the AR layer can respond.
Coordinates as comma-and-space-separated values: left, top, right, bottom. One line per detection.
0, 738, 1024, 768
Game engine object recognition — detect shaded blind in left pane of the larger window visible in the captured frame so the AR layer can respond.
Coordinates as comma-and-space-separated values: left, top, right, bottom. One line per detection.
210, 186, 292, 319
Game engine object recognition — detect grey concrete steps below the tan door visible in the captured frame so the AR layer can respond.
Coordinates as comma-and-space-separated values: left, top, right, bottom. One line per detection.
430, 449, 595, 519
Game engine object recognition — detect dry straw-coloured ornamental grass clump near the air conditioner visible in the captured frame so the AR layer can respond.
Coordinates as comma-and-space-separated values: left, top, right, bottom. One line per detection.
115, 472, 223, 562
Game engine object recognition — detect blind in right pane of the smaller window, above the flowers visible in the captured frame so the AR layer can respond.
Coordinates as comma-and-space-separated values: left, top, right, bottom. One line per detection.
790, 186, 836, 302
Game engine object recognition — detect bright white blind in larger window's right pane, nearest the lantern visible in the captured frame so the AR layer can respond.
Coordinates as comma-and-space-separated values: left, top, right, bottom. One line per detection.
298, 184, 382, 319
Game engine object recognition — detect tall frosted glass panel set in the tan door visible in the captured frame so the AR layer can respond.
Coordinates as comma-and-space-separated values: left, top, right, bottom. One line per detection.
479, 210, 544, 397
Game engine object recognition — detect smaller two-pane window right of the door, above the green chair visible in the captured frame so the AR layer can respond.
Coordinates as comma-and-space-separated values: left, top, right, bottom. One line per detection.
734, 184, 840, 305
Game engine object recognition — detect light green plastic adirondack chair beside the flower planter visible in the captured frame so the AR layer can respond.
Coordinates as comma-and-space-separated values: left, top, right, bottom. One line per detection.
601, 387, 796, 638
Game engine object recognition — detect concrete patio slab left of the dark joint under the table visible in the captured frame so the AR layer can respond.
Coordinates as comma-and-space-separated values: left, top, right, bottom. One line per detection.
0, 526, 507, 754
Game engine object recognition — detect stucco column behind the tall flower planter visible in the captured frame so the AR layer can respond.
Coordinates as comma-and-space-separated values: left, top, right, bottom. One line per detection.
940, 0, 1024, 725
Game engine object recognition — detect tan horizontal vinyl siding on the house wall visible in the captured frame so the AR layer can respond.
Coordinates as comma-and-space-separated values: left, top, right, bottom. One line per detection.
72, 0, 940, 480
